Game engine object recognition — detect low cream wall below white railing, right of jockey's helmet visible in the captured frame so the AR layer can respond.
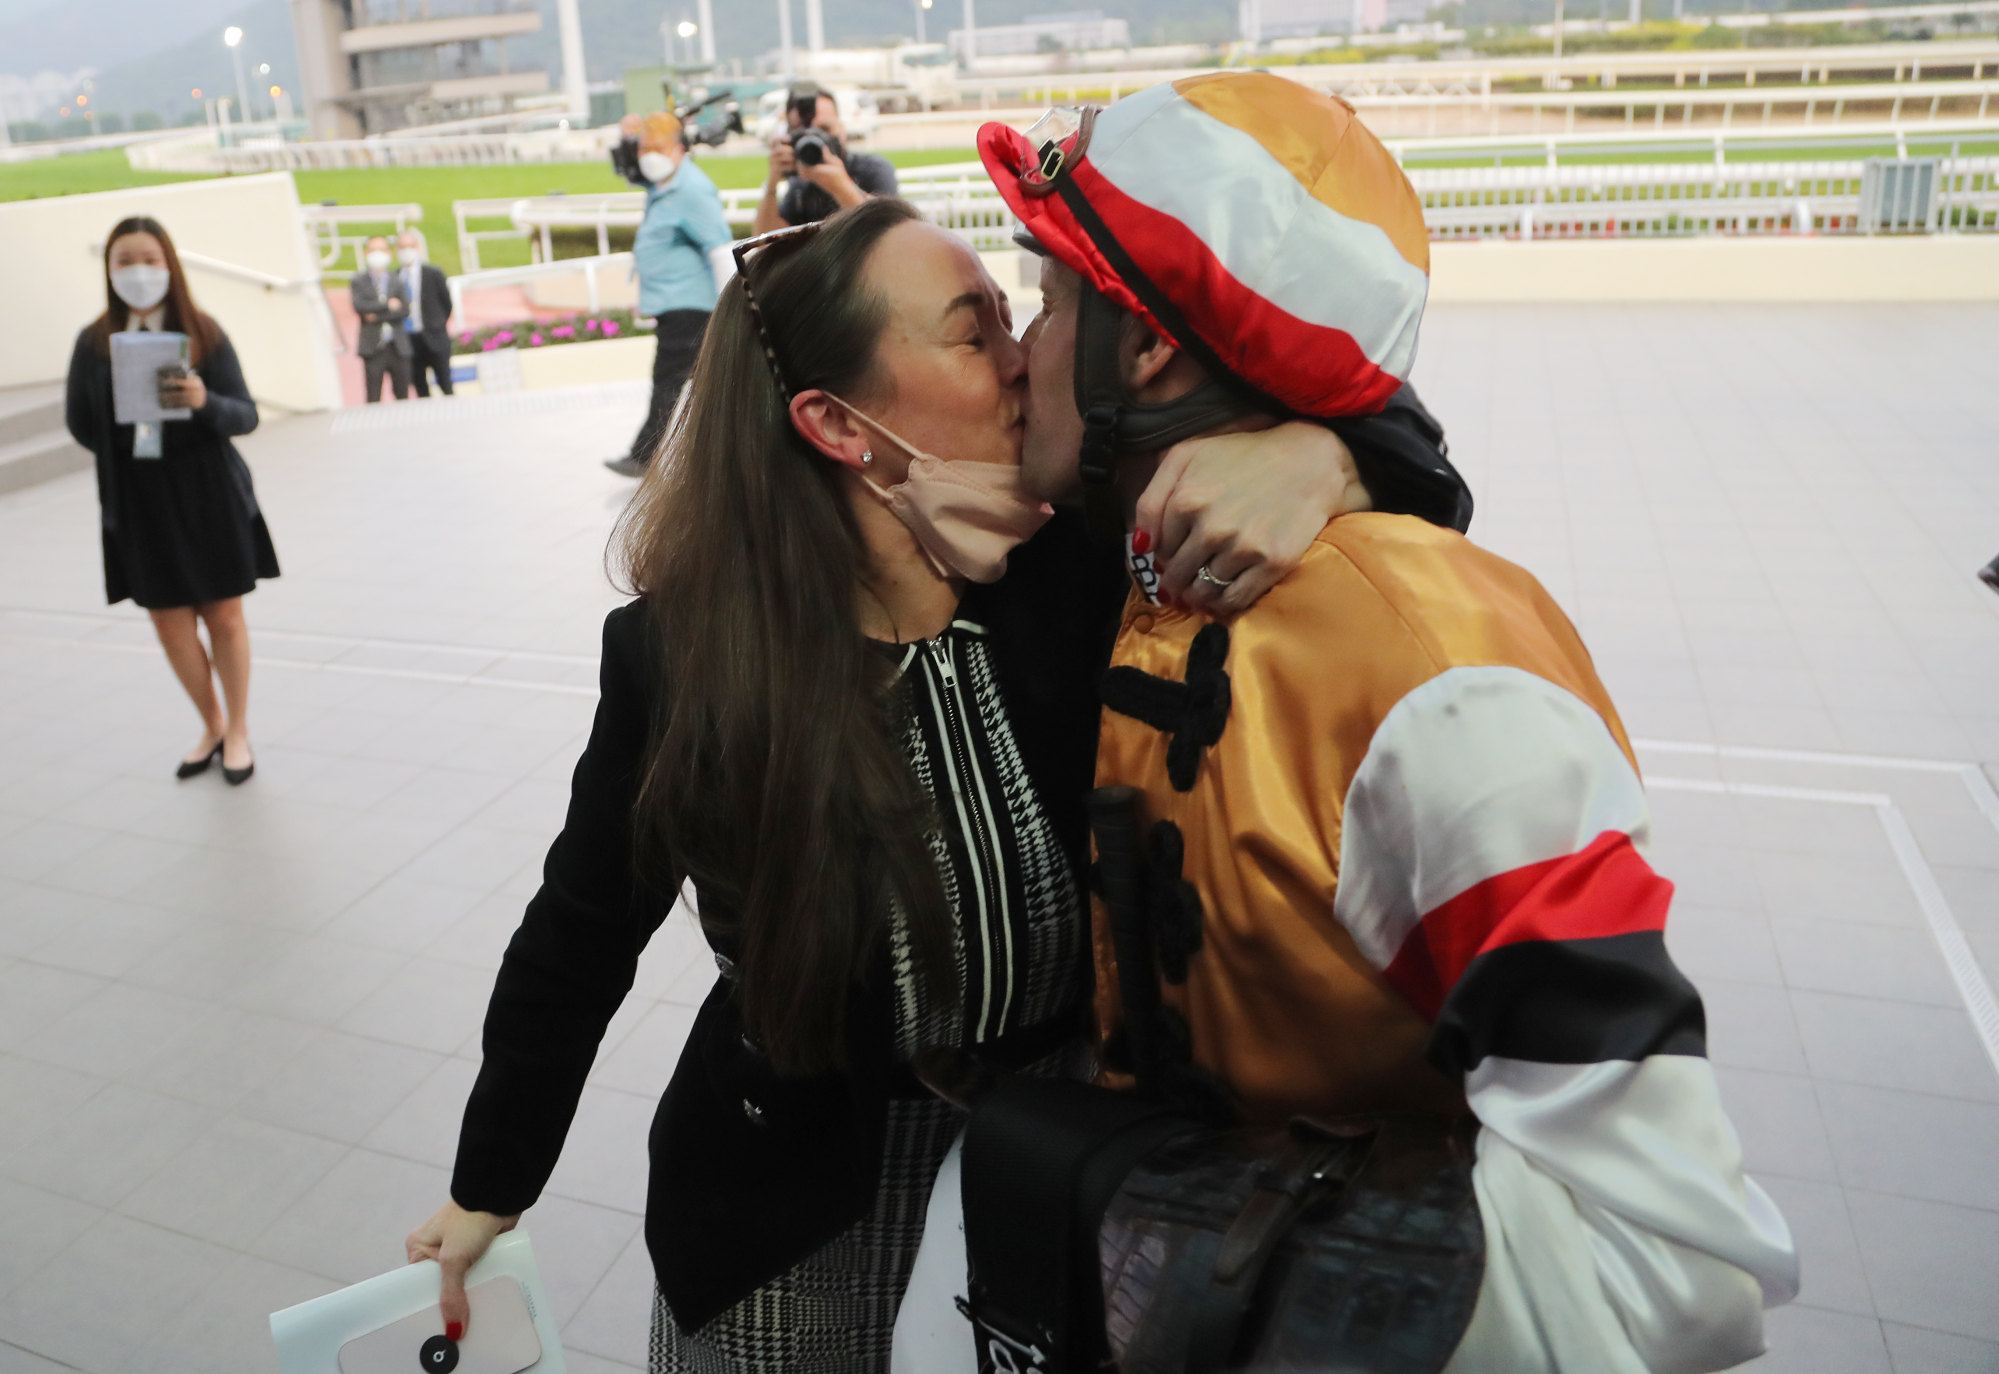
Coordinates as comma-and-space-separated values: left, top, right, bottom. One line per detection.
1429, 234, 1999, 306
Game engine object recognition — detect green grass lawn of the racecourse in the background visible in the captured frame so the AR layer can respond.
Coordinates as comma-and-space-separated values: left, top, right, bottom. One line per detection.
0, 148, 978, 274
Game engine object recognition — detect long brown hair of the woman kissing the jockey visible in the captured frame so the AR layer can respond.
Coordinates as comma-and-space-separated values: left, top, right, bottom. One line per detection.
616, 200, 952, 1074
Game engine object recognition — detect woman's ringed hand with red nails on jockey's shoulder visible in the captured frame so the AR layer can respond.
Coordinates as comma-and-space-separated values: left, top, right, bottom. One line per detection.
1137, 420, 1373, 618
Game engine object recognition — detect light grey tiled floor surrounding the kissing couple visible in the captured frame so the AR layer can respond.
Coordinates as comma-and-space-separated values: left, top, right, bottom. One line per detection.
0, 308, 1999, 1374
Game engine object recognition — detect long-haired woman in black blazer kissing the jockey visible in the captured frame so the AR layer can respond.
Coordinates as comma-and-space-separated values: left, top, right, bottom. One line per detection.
408, 200, 1439, 1374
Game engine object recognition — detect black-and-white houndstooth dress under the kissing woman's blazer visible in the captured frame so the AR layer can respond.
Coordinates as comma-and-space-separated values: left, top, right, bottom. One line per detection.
650, 620, 1087, 1374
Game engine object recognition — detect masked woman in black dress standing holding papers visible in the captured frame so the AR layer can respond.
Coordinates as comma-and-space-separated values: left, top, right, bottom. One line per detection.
66, 216, 278, 786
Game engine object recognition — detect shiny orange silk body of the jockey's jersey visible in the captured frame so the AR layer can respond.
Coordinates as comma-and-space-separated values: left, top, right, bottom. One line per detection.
1091, 512, 1631, 1122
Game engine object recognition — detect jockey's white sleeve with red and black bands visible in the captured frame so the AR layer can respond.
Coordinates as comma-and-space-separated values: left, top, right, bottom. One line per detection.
1335, 666, 1797, 1374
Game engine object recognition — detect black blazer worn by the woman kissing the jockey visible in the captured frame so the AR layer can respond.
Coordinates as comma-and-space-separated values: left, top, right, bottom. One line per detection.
452, 384, 1461, 1330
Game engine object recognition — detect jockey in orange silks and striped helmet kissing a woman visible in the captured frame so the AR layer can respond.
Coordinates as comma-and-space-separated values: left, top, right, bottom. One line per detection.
912, 72, 1797, 1374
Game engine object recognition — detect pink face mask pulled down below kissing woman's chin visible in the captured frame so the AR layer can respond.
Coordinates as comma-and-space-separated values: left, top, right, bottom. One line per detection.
828, 392, 1055, 582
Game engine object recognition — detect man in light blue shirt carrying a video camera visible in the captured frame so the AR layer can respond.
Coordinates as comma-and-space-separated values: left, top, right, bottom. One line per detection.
604, 112, 736, 478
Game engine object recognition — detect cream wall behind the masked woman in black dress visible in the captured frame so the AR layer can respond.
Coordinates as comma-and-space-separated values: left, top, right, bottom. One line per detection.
0, 172, 340, 410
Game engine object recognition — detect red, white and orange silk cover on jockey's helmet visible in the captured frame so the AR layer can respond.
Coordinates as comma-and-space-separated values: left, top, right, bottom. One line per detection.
980, 72, 1429, 416
